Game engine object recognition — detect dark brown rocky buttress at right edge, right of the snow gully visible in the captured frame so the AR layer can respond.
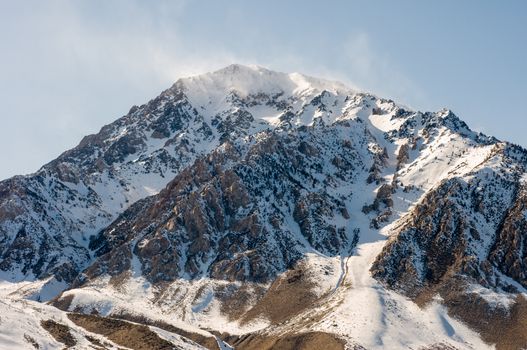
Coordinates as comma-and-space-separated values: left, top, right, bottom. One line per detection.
372, 144, 527, 297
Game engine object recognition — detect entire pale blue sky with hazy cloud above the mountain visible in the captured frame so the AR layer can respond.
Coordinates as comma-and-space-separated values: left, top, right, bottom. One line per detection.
0, 0, 527, 179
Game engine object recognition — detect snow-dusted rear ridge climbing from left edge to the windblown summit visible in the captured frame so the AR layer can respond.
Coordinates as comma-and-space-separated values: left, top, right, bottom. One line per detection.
0, 65, 354, 282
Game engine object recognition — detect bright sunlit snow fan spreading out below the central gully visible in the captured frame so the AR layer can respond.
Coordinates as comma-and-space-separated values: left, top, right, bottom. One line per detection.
306, 240, 493, 350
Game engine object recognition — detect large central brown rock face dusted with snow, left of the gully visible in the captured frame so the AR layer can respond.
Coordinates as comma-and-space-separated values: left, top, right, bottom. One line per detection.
86, 122, 371, 283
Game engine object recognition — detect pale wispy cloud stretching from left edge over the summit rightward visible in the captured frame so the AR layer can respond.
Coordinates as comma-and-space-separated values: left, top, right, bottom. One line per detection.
0, 0, 438, 177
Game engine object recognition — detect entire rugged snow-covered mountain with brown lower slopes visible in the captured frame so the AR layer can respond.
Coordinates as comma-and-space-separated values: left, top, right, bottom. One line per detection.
0, 65, 527, 349
